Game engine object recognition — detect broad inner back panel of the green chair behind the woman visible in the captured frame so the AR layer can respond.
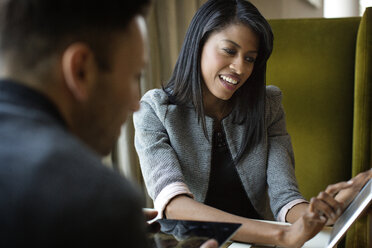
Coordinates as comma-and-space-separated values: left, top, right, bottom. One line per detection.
267, 18, 360, 199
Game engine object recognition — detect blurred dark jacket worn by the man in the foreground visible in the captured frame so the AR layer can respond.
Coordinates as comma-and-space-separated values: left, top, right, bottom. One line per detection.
0, 80, 146, 247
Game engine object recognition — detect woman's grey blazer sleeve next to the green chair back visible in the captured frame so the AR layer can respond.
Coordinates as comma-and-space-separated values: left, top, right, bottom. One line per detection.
266, 86, 305, 221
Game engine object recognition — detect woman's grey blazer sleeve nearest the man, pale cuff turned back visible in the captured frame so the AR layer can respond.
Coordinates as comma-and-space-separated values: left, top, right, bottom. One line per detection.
133, 90, 193, 217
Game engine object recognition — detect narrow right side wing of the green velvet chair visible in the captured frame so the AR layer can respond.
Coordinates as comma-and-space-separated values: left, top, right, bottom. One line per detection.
346, 8, 372, 248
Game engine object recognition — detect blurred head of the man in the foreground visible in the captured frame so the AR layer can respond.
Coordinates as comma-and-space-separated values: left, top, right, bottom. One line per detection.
0, 0, 150, 154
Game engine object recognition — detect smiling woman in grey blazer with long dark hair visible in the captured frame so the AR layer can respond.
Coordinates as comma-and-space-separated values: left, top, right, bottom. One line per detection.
134, 0, 366, 247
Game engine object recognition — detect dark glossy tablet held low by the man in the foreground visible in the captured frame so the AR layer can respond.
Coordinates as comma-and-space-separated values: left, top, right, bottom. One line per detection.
150, 219, 241, 248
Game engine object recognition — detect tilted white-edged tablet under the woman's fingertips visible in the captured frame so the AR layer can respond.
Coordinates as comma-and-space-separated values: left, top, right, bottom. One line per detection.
327, 179, 372, 248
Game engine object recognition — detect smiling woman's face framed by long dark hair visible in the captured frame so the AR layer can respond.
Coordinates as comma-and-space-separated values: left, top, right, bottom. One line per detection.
201, 24, 259, 100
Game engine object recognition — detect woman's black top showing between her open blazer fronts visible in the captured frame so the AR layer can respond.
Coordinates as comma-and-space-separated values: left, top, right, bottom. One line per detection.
205, 128, 261, 219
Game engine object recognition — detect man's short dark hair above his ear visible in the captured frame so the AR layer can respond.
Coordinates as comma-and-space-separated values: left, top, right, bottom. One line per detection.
0, 0, 151, 69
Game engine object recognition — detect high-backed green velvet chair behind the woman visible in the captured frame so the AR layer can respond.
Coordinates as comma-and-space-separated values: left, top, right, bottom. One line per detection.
267, 8, 372, 248
